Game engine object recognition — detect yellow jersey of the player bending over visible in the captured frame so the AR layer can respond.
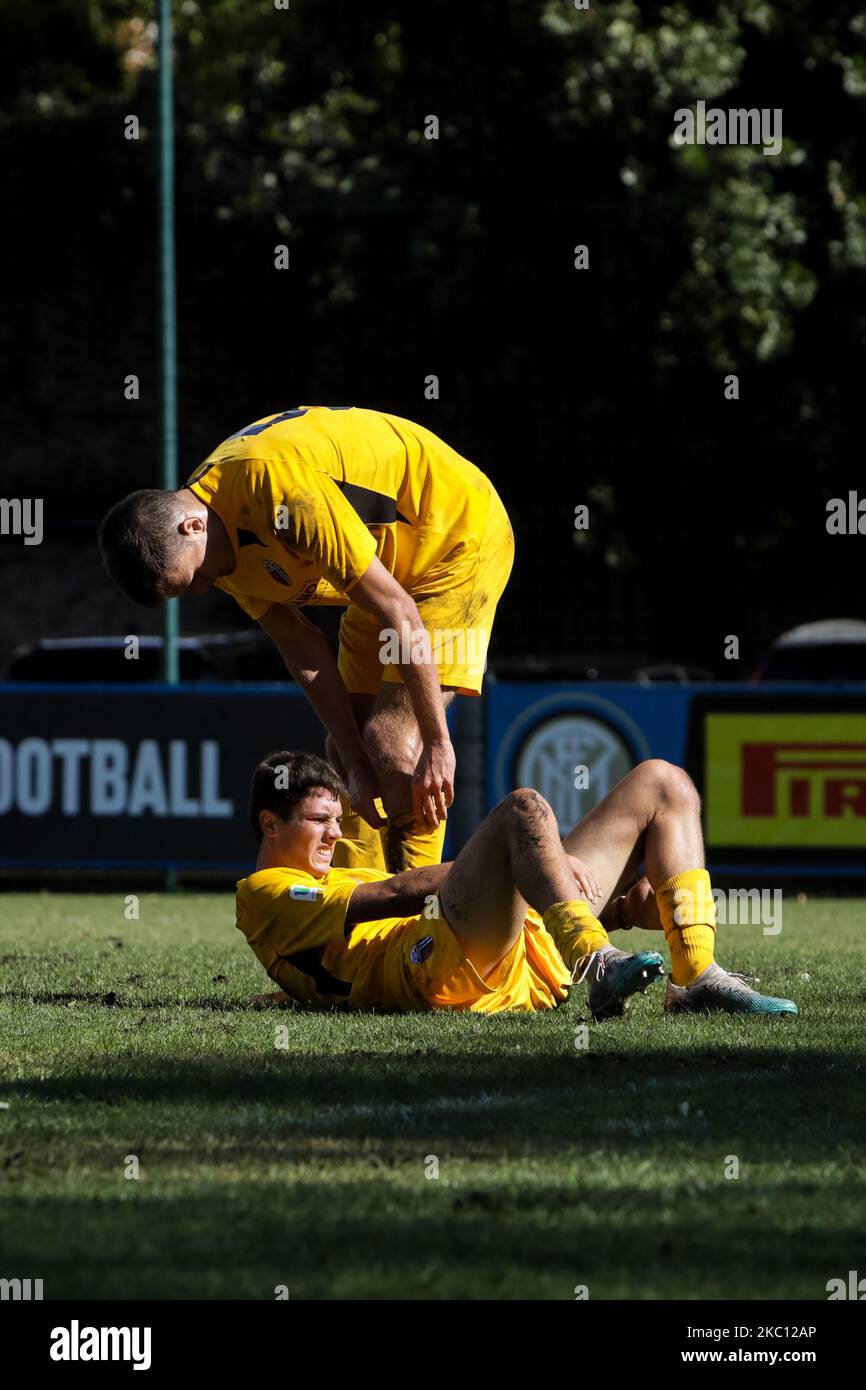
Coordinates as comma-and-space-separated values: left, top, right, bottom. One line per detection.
188, 406, 500, 619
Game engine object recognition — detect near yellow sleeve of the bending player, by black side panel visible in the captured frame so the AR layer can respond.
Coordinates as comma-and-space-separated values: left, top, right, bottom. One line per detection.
261, 463, 377, 594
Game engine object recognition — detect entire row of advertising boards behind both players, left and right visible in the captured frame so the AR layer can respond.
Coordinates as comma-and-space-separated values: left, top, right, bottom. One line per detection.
0, 681, 866, 877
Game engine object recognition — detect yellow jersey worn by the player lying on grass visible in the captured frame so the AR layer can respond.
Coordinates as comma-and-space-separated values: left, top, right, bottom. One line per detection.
236, 869, 418, 1008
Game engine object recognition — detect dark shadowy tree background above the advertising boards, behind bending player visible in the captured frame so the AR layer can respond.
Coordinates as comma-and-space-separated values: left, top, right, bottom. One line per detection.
0, 0, 866, 678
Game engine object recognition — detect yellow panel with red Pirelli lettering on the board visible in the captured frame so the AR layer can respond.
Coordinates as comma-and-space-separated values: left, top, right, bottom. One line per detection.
703, 712, 866, 849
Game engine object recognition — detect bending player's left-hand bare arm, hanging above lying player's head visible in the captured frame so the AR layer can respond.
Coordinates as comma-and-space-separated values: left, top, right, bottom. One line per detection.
259, 603, 384, 827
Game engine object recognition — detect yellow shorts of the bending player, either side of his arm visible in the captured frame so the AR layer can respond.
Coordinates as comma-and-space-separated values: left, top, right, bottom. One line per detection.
338, 489, 514, 695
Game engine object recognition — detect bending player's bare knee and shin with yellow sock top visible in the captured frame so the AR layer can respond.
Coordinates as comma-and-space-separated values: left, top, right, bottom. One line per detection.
364, 682, 456, 873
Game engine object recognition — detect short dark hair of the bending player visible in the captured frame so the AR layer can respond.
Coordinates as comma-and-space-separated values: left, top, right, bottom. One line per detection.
99, 488, 182, 607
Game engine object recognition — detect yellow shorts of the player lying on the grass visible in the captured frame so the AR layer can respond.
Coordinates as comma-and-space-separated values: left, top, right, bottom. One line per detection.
375, 899, 571, 1013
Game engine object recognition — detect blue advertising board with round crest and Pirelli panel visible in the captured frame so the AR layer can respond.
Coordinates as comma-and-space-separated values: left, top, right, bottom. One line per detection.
487, 681, 866, 877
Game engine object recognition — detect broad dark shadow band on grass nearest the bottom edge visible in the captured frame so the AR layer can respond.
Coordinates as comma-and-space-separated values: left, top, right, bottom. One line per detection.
4, 1166, 856, 1298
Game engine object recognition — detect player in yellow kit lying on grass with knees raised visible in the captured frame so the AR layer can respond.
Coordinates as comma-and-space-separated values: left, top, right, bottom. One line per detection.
238, 752, 796, 1020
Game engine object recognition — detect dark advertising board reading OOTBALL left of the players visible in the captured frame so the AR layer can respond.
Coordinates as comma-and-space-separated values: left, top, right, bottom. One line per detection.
0, 684, 324, 873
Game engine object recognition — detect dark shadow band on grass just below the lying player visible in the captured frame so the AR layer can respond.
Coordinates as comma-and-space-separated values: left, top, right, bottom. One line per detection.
0, 1041, 866, 1161
